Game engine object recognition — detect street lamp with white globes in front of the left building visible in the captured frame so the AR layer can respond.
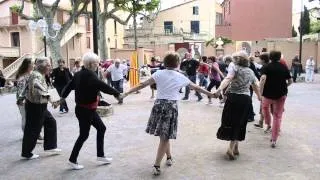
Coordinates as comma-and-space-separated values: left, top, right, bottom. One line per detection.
29, 18, 61, 56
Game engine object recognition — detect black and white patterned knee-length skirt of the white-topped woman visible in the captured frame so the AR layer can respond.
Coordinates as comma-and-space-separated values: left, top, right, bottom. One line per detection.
146, 99, 178, 139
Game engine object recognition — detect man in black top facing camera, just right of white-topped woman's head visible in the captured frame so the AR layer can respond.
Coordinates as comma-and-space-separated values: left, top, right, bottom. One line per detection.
181, 53, 203, 101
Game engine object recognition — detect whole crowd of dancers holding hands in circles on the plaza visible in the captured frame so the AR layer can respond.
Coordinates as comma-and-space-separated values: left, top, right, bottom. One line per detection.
16, 48, 296, 175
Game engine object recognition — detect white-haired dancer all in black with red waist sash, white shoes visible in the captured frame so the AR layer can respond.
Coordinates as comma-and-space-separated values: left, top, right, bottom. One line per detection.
61, 53, 120, 170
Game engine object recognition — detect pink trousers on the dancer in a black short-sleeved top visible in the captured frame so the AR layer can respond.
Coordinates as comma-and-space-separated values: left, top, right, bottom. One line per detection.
262, 96, 287, 141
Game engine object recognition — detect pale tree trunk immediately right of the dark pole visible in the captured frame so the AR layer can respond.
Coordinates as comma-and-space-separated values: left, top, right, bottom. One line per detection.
98, 16, 109, 60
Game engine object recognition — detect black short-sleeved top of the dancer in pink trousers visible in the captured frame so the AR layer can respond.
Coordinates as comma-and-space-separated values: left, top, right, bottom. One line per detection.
261, 62, 291, 99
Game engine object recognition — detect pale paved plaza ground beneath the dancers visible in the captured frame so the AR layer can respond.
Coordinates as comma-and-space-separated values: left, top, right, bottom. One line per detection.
0, 77, 320, 180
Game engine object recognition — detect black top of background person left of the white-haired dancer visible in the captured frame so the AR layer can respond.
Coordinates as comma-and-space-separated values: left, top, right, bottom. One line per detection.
51, 68, 72, 87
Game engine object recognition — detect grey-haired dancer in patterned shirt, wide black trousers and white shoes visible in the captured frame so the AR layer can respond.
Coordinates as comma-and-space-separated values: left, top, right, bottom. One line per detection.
21, 58, 61, 159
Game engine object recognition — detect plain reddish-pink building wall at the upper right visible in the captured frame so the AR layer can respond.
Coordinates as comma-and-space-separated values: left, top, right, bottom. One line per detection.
220, 0, 292, 41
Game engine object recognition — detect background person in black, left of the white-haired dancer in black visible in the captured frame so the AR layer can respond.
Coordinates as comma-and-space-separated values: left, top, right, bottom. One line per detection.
51, 59, 72, 113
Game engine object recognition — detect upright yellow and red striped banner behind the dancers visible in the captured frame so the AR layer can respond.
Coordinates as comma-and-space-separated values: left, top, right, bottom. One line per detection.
129, 51, 140, 88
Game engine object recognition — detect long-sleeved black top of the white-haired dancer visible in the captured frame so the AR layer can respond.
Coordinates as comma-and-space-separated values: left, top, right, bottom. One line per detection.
61, 68, 120, 104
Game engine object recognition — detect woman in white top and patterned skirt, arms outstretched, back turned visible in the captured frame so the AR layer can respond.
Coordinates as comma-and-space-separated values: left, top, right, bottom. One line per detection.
123, 53, 214, 175
